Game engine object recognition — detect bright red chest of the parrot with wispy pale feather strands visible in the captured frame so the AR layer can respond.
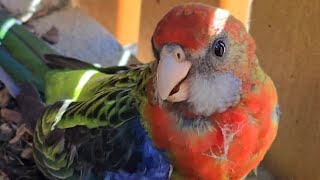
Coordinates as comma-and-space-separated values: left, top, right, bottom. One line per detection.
145, 99, 276, 180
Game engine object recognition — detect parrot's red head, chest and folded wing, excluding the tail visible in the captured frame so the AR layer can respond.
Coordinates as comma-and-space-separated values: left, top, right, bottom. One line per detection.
5, 3, 280, 180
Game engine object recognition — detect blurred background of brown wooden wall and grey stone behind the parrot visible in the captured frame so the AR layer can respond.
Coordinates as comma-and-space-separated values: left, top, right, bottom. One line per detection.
0, 0, 320, 180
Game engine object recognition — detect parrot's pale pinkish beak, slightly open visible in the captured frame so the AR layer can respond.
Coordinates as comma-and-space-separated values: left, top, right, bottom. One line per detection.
157, 45, 191, 102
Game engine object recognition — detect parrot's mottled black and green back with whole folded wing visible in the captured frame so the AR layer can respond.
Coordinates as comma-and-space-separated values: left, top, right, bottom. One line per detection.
34, 64, 159, 179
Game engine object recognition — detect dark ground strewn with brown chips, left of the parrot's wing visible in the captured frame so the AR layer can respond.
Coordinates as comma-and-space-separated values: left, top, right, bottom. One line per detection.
0, 82, 45, 180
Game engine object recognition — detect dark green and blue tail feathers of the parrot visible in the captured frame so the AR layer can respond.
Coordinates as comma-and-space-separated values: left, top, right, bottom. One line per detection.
0, 11, 55, 92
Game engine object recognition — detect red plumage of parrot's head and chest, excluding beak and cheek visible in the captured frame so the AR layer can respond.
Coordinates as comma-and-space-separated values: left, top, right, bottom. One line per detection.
143, 4, 279, 180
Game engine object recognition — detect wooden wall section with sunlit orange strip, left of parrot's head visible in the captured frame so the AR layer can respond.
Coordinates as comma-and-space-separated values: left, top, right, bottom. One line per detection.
72, 0, 141, 45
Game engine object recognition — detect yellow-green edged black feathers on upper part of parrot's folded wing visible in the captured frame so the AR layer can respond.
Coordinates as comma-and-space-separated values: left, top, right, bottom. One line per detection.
34, 64, 152, 179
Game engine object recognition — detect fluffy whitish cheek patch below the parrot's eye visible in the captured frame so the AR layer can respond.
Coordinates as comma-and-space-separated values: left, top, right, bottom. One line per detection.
188, 73, 241, 116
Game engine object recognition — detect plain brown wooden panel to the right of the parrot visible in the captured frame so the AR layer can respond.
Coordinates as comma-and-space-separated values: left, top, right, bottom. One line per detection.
250, 0, 320, 180
